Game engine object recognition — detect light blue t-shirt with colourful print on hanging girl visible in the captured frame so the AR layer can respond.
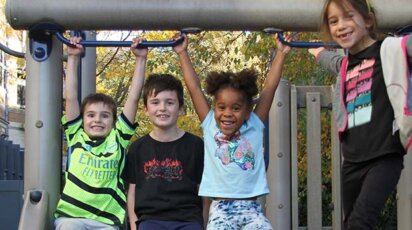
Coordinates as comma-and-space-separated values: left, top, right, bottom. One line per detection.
199, 110, 269, 199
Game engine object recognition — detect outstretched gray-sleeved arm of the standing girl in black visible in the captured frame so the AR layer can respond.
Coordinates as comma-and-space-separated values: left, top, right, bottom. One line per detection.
308, 47, 344, 74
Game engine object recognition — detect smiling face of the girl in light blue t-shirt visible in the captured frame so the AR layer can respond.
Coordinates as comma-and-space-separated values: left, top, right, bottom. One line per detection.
214, 88, 250, 136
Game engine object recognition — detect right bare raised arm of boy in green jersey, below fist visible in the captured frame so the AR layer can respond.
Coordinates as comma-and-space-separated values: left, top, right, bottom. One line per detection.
123, 57, 146, 123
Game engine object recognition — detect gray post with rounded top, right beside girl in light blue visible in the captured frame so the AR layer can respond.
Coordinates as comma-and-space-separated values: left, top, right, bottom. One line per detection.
266, 79, 292, 229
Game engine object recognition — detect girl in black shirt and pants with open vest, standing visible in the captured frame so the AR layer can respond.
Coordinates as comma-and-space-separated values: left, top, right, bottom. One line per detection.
310, 0, 412, 230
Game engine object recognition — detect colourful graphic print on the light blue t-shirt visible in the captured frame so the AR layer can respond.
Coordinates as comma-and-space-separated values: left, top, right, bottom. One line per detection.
214, 131, 255, 170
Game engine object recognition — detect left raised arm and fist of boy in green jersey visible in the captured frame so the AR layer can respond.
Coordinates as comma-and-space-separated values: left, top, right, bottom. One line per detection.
65, 37, 84, 121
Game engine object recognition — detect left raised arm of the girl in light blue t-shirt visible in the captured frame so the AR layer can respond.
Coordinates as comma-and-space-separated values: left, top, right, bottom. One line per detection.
173, 35, 210, 122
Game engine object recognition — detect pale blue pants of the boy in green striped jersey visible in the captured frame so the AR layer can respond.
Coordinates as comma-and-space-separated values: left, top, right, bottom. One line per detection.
54, 217, 119, 230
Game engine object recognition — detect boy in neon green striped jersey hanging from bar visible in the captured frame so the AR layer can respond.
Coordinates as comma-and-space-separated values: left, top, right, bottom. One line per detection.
55, 37, 148, 230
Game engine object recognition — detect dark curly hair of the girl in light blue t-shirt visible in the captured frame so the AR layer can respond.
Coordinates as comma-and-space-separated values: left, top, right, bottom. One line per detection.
205, 69, 258, 106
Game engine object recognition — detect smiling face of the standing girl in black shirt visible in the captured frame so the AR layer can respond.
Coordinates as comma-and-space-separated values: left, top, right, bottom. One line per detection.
327, 1, 374, 54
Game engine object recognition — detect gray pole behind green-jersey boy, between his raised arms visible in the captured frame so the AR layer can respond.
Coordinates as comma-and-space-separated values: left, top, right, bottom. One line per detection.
81, 31, 96, 100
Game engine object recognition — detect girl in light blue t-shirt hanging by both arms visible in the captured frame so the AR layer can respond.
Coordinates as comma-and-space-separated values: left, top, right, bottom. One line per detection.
174, 35, 290, 230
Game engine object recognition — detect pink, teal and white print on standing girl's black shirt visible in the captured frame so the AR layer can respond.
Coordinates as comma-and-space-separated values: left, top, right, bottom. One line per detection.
345, 59, 375, 129
